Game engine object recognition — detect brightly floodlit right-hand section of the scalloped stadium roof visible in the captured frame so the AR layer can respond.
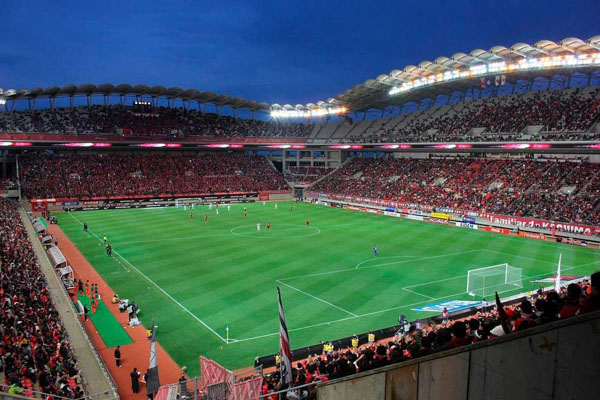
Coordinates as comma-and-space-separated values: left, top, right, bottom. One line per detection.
273, 35, 600, 112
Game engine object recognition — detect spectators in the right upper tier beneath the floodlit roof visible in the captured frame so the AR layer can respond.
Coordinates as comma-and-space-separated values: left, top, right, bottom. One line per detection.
352, 88, 600, 143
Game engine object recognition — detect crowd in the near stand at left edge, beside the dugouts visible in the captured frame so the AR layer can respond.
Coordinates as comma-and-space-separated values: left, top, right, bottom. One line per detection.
0, 198, 83, 398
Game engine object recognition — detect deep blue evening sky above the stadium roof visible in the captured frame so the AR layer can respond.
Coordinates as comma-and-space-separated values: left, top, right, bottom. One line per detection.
0, 0, 600, 104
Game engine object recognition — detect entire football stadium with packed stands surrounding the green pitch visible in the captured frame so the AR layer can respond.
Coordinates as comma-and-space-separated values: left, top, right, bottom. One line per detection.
0, 4, 600, 400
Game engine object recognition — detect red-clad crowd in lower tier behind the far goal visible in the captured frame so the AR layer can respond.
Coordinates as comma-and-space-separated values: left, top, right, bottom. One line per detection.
20, 152, 288, 198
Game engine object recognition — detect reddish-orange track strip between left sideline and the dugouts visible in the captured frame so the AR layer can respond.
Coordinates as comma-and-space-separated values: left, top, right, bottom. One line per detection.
48, 225, 181, 400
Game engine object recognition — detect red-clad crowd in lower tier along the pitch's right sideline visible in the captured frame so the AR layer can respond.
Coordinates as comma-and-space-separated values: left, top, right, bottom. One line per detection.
311, 157, 600, 225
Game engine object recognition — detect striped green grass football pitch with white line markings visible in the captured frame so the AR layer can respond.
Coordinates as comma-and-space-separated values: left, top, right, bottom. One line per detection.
59, 203, 600, 375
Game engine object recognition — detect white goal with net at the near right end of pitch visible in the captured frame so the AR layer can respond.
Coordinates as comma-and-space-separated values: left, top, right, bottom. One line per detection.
467, 263, 523, 297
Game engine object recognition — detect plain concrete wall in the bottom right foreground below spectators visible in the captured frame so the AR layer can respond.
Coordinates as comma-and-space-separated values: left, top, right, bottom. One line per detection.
317, 312, 600, 400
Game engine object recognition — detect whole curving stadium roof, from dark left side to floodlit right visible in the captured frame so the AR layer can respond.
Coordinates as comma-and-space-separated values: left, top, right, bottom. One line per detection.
0, 35, 600, 117
